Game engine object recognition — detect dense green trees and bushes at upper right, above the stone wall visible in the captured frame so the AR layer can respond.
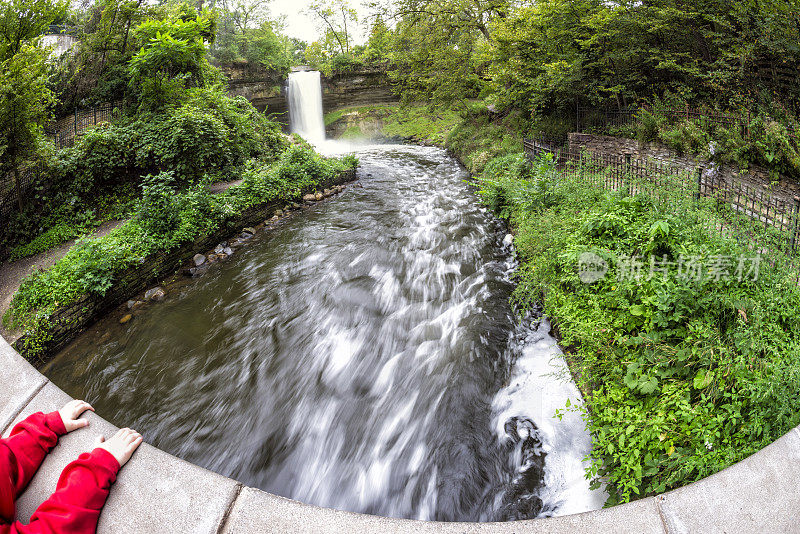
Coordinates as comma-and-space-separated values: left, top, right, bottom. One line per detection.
376, 0, 800, 178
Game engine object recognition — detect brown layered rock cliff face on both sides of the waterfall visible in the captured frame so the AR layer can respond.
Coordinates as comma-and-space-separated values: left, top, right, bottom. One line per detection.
218, 62, 397, 122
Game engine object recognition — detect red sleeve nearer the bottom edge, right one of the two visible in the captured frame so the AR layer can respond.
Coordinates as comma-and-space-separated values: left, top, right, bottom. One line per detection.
7, 449, 119, 534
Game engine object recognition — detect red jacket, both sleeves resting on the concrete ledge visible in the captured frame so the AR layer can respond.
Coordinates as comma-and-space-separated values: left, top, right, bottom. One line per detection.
0, 412, 119, 534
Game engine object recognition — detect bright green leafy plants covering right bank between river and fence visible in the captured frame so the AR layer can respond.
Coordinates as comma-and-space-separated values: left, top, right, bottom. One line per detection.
480, 155, 800, 504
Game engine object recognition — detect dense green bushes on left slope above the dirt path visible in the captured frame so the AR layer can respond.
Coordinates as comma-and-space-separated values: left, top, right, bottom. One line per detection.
4, 80, 288, 258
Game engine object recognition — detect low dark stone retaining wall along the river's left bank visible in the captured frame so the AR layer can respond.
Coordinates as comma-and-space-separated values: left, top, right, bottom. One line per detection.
14, 170, 356, 364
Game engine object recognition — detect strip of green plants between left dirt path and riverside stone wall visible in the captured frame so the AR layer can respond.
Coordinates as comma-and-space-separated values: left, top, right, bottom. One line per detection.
4, 145, 358, 342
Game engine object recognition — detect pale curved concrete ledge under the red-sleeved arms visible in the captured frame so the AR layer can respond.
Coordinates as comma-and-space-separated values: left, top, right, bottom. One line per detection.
0, 338, 800, 534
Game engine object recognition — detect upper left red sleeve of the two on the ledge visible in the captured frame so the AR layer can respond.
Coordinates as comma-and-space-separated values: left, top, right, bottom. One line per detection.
0, 412, 67, 500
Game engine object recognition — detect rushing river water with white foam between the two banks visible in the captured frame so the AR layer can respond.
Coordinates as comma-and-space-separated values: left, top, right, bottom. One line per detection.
45, 145, 605, 521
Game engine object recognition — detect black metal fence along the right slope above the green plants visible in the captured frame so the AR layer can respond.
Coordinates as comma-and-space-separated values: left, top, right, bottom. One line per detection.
523, 139, 800, 284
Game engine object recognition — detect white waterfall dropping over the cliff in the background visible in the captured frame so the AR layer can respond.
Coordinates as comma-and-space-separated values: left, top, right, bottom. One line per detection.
287, 71, 325, 147
